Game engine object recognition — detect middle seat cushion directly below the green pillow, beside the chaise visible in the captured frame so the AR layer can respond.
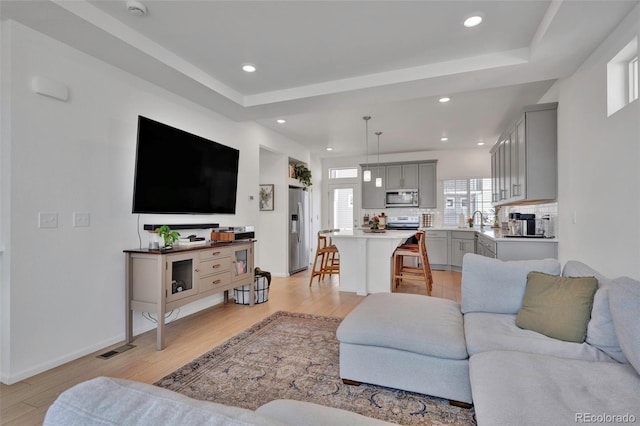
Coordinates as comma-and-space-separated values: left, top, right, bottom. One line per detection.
464, 312, 613, 362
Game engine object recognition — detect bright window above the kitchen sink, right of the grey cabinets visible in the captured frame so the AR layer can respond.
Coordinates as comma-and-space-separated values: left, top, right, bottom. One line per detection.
443, 178, 495, 226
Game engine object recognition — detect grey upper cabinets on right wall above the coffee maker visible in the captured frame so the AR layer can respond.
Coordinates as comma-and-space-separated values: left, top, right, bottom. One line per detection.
491, 102, 558, 205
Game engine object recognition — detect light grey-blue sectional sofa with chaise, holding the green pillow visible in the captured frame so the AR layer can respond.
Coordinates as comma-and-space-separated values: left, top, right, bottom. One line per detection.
338, 254, 640, 426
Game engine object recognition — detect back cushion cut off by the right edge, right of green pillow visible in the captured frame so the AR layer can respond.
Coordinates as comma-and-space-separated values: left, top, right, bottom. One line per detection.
609, 277, 640, 373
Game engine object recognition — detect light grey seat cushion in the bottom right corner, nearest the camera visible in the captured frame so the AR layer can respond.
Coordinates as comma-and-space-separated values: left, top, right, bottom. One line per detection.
469, 351, 640, 426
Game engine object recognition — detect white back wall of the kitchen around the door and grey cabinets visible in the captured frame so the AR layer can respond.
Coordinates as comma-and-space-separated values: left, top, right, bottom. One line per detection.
321, 147, 491, 228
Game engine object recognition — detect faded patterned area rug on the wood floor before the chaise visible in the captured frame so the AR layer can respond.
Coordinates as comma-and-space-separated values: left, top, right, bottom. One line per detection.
155, 311, 475, 425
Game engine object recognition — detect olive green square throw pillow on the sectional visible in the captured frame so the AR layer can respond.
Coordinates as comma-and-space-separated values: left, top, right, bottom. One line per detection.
516, 272, 598, 343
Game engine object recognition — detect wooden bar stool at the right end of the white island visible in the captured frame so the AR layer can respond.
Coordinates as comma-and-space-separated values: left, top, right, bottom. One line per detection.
393, 231, 433, 296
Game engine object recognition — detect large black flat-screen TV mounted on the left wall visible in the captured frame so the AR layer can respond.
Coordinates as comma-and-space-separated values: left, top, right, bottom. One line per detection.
132, 116, 240, 214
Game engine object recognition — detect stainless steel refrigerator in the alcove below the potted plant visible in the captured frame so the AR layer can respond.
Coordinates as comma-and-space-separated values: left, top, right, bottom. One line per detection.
289, 188, 309, 274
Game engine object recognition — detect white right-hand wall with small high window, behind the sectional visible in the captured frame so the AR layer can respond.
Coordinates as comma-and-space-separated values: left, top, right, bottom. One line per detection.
544, 5, 640, 279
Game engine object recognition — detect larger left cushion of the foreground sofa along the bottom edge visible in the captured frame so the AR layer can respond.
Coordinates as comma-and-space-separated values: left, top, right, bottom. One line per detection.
44, 377, 283, 426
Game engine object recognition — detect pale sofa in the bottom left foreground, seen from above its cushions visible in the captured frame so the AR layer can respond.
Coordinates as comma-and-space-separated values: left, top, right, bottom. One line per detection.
44, 377, 391, 426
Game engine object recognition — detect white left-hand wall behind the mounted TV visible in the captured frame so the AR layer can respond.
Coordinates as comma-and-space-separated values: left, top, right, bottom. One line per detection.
0, 22, 309, 383
